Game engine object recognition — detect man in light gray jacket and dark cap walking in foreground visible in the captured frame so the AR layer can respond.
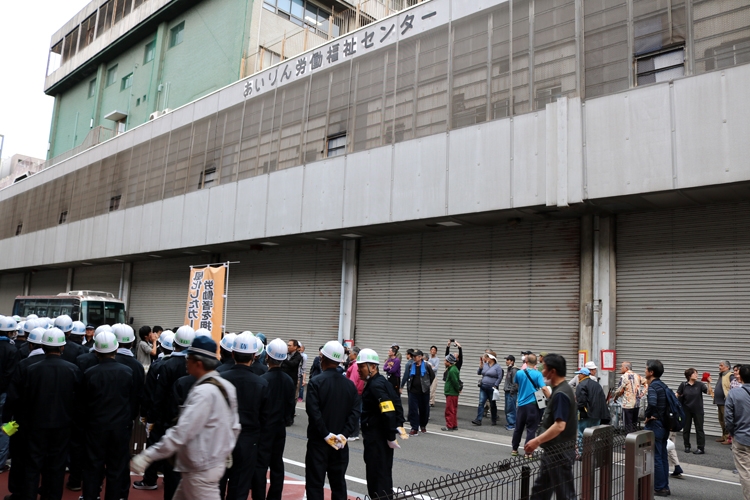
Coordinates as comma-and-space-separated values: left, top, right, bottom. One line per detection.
130, 336, 240, 500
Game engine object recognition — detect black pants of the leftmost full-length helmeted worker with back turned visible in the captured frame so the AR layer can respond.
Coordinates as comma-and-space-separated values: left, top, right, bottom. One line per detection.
23, 427, 70, 500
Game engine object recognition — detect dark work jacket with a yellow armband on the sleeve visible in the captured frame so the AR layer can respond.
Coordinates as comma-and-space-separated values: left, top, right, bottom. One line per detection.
361, 373, 404, 441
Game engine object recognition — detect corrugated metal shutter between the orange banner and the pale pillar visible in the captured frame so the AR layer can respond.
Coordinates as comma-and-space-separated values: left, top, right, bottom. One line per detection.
226, 244, 342, 355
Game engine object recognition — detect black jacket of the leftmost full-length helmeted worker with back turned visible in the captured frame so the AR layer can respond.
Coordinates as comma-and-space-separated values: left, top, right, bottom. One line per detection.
19, 354, 83, 430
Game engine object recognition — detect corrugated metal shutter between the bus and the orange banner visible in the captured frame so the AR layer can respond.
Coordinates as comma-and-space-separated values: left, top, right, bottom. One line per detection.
128, 255, 208, 331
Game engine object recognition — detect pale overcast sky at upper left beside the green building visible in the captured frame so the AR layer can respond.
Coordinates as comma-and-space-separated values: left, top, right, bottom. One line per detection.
0, 0, 90, 158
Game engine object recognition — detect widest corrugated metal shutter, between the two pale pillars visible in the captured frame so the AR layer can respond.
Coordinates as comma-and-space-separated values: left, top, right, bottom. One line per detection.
356, 220, 580, 405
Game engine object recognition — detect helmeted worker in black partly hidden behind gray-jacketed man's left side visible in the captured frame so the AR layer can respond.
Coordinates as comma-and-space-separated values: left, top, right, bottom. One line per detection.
151, 325, 195, 500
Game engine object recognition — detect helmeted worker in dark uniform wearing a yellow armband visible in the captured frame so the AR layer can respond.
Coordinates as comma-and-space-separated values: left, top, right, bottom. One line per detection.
357, 349, 406, 498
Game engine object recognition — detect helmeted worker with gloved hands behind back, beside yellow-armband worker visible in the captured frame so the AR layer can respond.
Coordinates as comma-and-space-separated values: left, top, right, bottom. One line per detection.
305, 340, 360, 500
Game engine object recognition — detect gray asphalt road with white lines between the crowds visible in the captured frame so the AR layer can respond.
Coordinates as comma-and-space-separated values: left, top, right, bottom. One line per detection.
284, 400, 742, 500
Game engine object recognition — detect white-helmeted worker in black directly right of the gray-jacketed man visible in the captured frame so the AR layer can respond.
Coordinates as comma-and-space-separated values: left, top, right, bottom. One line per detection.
219, 332, 270, 500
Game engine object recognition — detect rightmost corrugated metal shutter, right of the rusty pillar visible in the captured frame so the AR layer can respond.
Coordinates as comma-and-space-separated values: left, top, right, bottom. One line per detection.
617, 203, 750, 435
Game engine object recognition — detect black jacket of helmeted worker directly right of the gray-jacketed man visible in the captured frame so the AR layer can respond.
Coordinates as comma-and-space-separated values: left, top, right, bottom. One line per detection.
221, 364, 270, 434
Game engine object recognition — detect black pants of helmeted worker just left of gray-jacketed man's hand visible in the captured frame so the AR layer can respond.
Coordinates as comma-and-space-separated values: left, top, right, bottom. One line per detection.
83, 426, 130, 500
